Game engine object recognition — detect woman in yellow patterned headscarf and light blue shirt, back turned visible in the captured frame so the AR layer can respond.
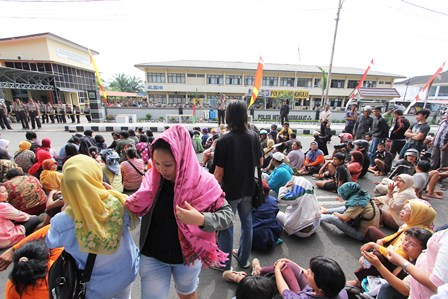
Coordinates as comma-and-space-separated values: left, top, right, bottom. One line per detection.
46, 155, 139, 298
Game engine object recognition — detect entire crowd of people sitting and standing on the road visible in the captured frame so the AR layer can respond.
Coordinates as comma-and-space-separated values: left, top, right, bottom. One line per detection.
0, 102, 448, 299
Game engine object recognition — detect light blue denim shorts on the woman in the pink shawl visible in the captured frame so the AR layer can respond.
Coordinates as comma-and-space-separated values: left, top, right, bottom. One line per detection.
139, 254, 202, 299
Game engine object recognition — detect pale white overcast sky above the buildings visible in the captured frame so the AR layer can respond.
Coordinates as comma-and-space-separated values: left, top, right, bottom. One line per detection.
0, 0, 448, 81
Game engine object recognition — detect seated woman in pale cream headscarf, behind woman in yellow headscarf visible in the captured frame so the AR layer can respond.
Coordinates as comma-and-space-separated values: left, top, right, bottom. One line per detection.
373, 173, 417, 230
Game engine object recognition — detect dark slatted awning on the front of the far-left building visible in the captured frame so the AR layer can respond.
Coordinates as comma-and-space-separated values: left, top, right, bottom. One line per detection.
0, 66, 54, 90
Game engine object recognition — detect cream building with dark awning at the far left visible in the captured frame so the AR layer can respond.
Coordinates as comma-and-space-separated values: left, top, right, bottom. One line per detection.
0, 33, 99, 107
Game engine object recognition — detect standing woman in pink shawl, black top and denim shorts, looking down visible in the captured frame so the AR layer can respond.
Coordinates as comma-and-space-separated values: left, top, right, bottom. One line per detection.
126, 125, 233, 299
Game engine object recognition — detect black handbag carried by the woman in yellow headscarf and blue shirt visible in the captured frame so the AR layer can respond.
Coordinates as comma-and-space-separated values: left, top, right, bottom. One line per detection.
48, 250, 96, 299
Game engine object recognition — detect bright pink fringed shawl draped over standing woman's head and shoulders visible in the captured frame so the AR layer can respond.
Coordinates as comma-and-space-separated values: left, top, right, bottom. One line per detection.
126, 125, 227, 266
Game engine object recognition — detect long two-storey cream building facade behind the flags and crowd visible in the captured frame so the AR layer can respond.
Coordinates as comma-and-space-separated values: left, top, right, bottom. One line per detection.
135, 60, 404, 111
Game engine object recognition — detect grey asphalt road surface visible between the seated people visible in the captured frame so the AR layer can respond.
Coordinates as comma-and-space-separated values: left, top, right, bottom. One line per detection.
0, 124, 448, 298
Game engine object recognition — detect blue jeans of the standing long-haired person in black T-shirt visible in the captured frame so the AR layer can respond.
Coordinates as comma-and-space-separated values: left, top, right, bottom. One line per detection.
218, 196, 252, 270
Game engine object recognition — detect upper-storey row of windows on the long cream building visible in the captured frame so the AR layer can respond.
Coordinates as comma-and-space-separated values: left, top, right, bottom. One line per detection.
146, 73, 378, 89
